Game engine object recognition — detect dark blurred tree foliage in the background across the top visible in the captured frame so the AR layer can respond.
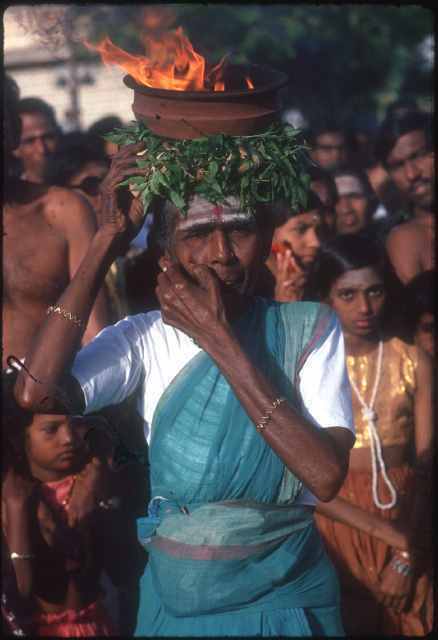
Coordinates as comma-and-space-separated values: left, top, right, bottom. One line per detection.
62, 3, 434, 125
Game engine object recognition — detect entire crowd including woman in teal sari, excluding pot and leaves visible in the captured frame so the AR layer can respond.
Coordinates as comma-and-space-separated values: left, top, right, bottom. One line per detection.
2, 69, 435, 637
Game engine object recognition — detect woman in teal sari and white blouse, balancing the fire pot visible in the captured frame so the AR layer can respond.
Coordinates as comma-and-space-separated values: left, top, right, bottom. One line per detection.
16, 143, 354, 637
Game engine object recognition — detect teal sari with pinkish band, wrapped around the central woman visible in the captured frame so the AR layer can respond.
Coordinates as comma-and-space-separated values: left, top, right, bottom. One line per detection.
136, 299, 343, 637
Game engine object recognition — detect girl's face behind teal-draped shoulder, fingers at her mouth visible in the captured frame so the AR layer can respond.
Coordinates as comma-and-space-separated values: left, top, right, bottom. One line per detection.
272, 209, 322, 268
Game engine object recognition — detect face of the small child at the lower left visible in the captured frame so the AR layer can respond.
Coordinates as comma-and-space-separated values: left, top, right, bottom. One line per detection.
25, 414, 86, 482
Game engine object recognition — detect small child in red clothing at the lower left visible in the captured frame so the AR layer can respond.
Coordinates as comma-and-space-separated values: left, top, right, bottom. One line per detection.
2, 370, 119, 637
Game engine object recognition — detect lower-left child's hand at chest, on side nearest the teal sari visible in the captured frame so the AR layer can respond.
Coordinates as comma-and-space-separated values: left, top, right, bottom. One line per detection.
67, 457, 108, 527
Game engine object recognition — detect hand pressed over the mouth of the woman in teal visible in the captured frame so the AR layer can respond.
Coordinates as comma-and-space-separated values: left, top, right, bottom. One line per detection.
156, 257, 228, 348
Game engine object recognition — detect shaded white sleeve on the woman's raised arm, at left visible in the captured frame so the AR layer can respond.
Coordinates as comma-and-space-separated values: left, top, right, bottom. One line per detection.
71, 316, 148, 413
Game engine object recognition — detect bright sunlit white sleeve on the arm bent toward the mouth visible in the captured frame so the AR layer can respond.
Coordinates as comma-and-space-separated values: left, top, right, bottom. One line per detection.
299, 313, 354, 434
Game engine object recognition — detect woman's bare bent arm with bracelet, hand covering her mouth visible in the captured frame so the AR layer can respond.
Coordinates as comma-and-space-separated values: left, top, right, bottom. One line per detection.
157, 260, 354, 501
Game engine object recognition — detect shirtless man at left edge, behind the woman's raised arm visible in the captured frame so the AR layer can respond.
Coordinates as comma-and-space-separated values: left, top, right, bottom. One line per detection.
2, 77, 109, 369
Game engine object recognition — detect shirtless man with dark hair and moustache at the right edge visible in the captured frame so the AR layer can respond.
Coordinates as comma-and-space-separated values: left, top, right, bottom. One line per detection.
376, 111, 435, 284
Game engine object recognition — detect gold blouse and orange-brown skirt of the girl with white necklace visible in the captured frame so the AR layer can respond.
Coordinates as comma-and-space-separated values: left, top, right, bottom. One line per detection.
315, 338, 433, 636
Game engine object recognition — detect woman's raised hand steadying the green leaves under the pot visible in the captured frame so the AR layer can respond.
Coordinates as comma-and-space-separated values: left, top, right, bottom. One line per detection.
97, 142, 144, 246
